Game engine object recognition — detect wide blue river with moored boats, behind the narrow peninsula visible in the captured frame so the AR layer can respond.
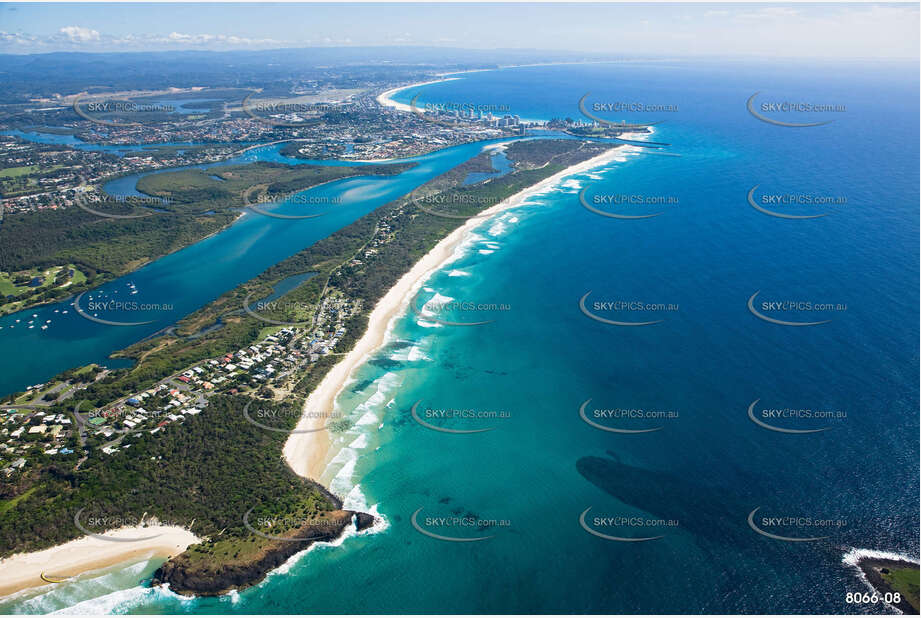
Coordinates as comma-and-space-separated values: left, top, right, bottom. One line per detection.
0, 133, 524, 394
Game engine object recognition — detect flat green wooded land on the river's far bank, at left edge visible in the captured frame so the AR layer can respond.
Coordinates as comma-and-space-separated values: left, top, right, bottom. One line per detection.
0, 162, 410, 313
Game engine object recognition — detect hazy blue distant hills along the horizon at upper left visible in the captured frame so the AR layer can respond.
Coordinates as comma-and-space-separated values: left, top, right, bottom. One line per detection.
0, 47, 640, 104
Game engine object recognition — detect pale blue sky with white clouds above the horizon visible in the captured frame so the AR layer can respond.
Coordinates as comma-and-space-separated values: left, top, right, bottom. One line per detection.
0, 3, 919, 59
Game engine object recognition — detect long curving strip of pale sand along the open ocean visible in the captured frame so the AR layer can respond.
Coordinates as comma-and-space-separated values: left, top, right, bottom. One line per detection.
282, 145, 624, 482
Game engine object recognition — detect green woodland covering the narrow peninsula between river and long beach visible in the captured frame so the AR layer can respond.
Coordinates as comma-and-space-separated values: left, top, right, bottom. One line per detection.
0, 140, 609, 588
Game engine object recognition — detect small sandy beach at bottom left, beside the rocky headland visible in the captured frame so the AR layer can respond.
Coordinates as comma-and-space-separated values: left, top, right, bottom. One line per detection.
0, 526, 199, 596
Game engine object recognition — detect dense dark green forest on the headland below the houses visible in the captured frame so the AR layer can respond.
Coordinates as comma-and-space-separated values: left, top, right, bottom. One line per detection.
0, 395, 360, 592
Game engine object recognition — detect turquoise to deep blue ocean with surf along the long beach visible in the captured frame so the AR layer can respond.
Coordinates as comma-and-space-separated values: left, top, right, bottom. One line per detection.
3, 63, 919, 613
